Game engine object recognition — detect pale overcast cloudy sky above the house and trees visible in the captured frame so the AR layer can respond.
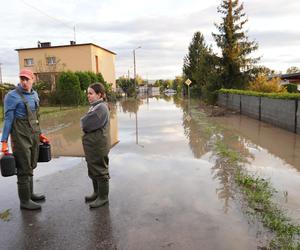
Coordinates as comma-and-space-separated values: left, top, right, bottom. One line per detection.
0, 0, 300, 83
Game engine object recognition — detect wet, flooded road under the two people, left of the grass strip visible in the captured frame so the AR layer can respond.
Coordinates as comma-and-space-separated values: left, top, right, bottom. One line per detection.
0, 96, 298, 250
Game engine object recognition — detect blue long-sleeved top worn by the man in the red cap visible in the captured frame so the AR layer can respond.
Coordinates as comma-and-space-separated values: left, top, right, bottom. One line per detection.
1, 84, 40, 141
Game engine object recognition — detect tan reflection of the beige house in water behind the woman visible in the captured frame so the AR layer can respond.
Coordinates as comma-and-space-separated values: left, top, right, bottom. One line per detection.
41, 105, 118, 157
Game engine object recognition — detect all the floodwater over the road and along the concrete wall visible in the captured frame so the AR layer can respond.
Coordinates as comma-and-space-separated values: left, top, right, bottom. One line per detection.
0, 97, 300, 250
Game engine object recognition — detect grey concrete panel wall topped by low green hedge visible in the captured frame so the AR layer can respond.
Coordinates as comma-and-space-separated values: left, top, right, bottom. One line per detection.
218, 89, 300, 134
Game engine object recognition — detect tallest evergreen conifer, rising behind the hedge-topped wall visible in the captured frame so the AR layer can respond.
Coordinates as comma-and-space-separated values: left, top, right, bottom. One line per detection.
213, 0, 259, 89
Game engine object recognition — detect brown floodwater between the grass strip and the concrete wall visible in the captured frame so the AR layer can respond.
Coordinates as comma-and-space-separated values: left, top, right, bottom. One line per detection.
214, 112, 300, 220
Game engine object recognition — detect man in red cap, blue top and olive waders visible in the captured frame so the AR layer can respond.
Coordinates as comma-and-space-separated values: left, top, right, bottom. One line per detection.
1, 69, 49, 210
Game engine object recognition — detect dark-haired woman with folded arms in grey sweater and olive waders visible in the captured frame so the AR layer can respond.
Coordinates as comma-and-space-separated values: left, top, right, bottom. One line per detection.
80, 83, 110, 208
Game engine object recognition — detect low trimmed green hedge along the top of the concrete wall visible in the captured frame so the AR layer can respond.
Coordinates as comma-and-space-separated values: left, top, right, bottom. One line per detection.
218, 89, 300, 100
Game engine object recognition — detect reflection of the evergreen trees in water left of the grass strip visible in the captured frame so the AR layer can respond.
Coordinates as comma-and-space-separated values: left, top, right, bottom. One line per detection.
174, 99, 238, 213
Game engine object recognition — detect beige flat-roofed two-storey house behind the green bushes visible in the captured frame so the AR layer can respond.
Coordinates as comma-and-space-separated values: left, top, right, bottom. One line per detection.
16, 41, 116, 90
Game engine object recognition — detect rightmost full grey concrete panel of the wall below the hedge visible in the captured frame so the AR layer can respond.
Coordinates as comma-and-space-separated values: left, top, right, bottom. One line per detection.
261, 97, 296, 132
